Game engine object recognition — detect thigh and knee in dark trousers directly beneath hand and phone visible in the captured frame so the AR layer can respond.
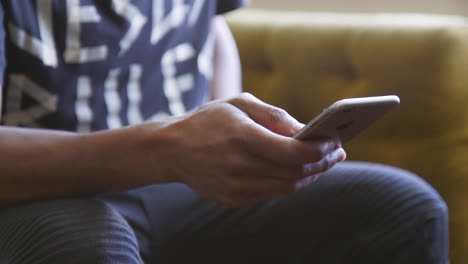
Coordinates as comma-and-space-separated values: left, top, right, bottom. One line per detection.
99, 162, 447, 263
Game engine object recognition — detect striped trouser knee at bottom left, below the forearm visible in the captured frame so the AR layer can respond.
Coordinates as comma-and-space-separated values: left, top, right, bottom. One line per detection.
0, 200, 141, 263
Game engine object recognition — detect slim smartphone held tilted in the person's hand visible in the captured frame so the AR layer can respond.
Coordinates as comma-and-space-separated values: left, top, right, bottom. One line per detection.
293, 95, 400, 145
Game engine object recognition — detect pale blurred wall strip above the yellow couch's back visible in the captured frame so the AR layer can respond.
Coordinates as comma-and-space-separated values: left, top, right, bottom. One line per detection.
251, 0, 468, 16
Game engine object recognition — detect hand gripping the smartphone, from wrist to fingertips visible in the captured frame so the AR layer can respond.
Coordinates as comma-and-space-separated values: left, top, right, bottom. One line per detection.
149, 93, 346, 207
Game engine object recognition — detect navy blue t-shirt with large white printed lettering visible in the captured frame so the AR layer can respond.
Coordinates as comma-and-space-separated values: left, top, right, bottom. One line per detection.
0, 0, 243, 132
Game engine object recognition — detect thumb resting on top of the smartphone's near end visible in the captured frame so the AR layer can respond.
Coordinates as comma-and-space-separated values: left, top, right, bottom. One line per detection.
228, 93, 304, 137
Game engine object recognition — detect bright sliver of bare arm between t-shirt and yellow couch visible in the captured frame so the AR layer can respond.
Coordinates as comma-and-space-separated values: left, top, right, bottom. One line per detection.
211, 16, 242, 99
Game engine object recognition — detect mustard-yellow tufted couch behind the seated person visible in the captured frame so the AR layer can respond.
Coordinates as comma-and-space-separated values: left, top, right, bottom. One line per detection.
228, 10, 468, 264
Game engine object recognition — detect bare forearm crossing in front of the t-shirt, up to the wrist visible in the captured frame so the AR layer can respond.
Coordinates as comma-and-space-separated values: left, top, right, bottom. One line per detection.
0, 122, 176, 205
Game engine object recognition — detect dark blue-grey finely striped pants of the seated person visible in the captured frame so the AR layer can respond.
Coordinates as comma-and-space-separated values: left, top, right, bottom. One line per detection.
0, 162, 449, 264
